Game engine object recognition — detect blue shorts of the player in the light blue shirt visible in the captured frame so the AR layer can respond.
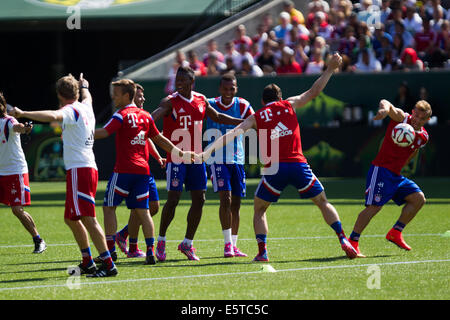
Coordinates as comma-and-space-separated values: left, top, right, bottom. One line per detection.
210, 163, 245, 198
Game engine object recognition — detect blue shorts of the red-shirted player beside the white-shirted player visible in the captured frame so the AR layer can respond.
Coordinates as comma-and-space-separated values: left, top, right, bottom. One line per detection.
103, 172, 159, 209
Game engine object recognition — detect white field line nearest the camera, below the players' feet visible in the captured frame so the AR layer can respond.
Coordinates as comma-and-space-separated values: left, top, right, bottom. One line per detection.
0, 259, 450, 292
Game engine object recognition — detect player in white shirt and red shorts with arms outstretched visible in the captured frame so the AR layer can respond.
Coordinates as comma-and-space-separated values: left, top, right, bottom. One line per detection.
14, 74, 118, 277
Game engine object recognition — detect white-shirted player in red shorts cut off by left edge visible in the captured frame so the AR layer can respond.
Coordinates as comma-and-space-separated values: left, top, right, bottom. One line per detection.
0, 92, 47, 253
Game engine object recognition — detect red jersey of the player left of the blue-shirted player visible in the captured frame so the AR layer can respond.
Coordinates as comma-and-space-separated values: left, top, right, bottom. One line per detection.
163, 91, 206, 162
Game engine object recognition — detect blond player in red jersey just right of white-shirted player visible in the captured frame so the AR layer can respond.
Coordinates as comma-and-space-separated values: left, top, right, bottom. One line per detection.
95, 79, 192, 264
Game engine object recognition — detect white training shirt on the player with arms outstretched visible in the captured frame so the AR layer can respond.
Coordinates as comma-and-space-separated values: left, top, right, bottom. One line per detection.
59, 101, 97, 170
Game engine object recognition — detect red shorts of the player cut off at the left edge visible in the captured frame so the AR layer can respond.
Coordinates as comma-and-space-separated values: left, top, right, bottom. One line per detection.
0, 173, 31, 207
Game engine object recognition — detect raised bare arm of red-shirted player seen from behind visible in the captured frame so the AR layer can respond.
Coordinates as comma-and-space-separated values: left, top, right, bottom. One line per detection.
287, 53, 342, 108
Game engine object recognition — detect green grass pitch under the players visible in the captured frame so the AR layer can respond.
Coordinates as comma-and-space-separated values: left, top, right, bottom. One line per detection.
0, 178, 450, 300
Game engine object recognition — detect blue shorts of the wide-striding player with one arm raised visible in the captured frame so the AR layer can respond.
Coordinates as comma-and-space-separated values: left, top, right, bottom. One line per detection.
255, 162, 324, 202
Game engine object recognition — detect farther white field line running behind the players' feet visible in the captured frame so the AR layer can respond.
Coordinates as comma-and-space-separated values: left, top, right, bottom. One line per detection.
0, 233, 442, 249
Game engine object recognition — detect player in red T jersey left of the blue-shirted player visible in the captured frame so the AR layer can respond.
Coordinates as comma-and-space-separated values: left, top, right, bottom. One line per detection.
152, 67, 243, 261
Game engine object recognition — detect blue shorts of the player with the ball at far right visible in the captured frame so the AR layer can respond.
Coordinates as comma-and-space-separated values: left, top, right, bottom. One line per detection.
366, 165, 422, 206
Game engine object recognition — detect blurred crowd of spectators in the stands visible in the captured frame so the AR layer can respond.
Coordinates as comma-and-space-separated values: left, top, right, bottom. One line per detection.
167, 0, 450, 91
